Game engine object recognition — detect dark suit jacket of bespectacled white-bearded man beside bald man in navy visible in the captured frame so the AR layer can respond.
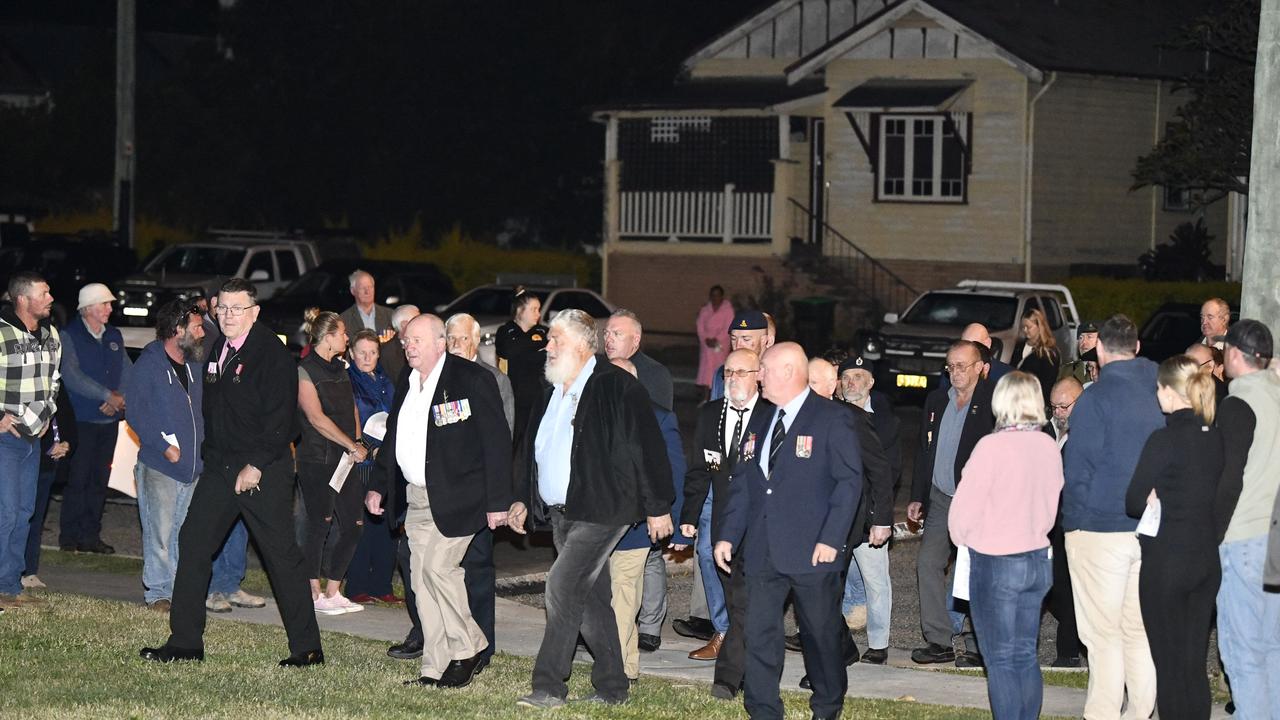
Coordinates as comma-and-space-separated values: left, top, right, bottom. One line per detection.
678, 397, 774, 537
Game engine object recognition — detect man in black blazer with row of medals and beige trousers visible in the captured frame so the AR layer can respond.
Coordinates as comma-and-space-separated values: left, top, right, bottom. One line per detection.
366, 315, 511, 688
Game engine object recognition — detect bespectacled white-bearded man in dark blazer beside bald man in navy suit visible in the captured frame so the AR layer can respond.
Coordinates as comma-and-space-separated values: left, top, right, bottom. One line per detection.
680, 350, 773, 700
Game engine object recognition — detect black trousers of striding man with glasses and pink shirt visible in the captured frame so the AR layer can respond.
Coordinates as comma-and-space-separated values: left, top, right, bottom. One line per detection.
169, 456, 320, 655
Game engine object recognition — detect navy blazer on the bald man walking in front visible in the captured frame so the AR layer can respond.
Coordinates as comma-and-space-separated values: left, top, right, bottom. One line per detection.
714, 392, 863, 575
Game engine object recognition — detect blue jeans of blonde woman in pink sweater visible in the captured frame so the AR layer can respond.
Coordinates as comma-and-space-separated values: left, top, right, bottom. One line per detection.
969, 547, 1053, 720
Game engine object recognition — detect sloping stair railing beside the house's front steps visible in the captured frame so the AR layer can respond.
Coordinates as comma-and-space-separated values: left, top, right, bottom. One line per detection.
787, 197, 920, 313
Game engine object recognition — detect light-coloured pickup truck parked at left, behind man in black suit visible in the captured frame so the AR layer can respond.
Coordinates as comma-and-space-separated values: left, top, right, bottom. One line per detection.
111, 231, 357, 325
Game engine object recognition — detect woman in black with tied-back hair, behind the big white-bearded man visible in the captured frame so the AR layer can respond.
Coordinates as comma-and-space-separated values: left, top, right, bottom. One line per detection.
494, 287, 547, 446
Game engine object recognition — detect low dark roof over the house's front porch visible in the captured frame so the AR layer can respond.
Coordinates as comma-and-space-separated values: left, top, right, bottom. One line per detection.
594, 77, 827, 111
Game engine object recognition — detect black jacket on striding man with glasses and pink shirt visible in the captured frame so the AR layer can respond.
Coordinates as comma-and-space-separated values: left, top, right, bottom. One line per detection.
201, 323, 298, 471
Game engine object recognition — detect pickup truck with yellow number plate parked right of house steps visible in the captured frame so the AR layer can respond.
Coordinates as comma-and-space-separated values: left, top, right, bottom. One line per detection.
861, 281, 1080, 395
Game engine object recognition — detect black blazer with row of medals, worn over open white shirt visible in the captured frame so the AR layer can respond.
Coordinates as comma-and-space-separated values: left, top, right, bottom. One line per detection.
372, 354, 512, 538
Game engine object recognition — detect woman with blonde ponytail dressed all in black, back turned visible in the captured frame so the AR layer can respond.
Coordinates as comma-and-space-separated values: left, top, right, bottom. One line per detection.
1125, 355, 1225, 720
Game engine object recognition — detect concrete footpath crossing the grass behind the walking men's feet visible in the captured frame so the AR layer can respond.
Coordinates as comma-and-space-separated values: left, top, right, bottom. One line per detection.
32, 566, 1162, 717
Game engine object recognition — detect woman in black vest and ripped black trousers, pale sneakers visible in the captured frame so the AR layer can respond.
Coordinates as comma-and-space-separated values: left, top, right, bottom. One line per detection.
297, 307, 367, 615
